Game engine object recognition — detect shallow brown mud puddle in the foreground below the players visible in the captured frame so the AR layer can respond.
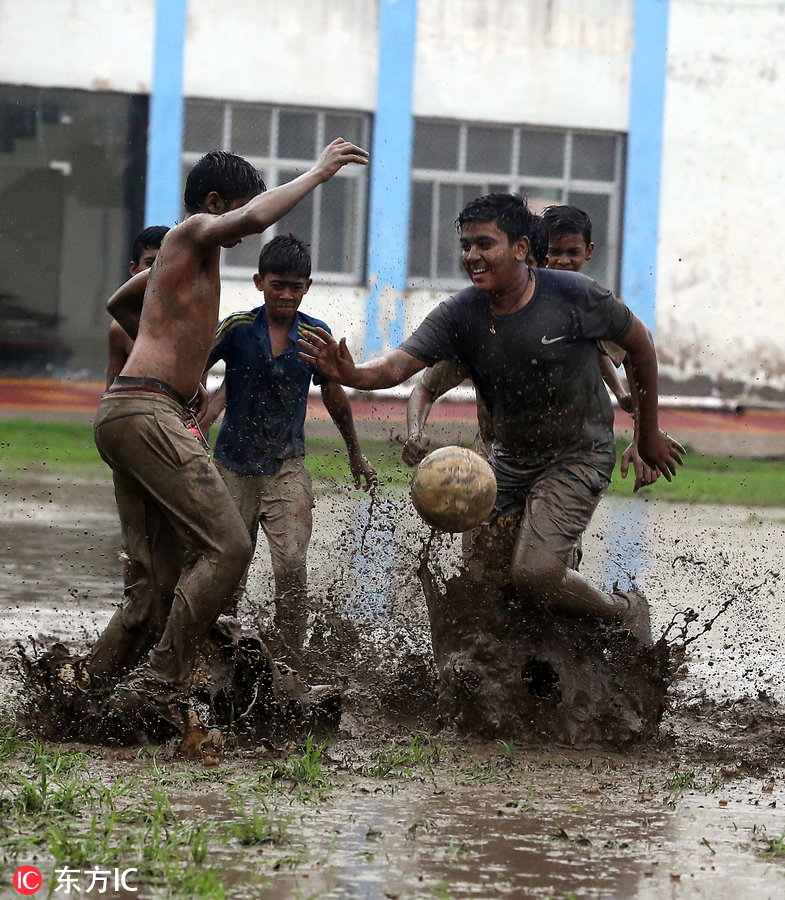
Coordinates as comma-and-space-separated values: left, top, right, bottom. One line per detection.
0, 735, 785, 900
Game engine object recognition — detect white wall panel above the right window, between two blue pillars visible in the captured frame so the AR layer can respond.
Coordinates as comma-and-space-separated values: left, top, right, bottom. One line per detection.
414, 0, 633, 131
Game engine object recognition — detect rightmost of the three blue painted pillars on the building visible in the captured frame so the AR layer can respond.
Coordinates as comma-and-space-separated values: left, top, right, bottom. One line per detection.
621, 0, 669, 330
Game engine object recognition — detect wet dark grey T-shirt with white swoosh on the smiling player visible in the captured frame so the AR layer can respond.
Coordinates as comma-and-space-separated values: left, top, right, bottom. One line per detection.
401, 269, 632, 466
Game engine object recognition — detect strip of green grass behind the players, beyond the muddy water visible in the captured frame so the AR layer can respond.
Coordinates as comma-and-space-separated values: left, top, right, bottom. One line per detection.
0, 419, 785, 507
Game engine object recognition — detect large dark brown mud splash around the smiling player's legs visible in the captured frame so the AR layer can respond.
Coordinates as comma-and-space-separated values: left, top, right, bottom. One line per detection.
418, 515, 681, 747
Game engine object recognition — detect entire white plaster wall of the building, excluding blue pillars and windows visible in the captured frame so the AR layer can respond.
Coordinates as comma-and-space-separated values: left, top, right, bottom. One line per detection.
6, 0, 785, 394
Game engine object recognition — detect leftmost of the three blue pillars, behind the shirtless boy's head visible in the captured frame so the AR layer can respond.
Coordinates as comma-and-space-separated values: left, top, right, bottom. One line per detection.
144, 0, 188, 226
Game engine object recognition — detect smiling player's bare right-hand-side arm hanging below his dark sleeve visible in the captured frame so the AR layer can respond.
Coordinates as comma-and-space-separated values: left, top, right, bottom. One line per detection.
616, 316, 684, 481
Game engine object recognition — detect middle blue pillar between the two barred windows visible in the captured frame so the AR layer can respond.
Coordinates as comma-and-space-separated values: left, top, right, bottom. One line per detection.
364, 0, 417, 358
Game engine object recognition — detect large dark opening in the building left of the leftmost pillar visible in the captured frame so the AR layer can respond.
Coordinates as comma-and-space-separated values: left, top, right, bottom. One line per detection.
0, 85, 147, 379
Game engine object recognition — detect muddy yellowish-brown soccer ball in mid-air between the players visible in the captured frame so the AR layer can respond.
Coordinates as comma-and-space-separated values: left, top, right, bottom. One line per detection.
412, 447, 496, 531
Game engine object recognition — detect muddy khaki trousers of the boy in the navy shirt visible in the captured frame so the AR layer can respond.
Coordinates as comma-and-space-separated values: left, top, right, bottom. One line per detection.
216, 456, 314, 653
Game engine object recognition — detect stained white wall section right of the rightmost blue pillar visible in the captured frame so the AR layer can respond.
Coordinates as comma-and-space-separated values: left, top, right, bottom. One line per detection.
657, 0, 785, 390
